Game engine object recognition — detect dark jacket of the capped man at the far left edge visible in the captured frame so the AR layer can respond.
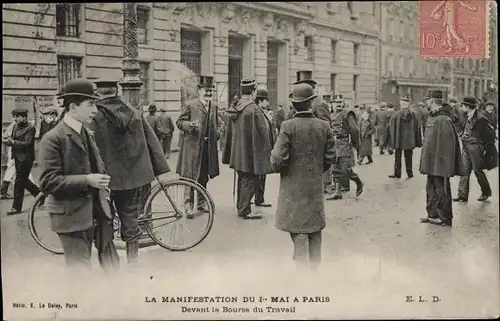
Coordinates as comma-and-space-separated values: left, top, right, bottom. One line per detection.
8, 123, 36, 162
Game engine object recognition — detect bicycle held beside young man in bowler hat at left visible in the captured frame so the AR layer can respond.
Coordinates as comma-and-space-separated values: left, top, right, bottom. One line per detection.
28, 177, 215, 254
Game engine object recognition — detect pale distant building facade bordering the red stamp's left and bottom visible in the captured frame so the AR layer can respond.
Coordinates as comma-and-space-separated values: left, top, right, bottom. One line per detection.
379, 1, 451, 107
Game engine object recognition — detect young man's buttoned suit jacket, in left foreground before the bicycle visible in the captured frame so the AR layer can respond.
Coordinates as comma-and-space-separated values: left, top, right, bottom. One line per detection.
39, 121, 105, 233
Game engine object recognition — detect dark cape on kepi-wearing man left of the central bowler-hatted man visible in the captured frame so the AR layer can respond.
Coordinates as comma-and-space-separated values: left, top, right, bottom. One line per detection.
222, 96, 275, 175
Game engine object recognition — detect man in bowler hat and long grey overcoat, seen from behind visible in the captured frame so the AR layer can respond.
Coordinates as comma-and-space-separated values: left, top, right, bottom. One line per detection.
271, 83, 336, 268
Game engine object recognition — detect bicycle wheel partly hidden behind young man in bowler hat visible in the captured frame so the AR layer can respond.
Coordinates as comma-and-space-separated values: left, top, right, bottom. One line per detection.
28, 193, 64, 254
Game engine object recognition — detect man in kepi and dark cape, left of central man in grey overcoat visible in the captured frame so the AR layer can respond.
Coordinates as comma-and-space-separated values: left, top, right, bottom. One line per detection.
222, 79, 274, 219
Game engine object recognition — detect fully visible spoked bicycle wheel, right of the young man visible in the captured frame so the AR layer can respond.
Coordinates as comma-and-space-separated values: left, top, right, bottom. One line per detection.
140, 178, 215, 251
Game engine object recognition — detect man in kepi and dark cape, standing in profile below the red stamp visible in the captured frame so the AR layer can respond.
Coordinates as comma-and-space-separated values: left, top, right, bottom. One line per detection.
420, 90, 465, 226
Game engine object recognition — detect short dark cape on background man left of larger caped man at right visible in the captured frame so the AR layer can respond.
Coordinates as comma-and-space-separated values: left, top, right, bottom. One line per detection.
388, 108, 422, 149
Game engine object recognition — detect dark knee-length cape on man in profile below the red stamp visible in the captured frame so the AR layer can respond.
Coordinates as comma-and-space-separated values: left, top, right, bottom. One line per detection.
420, 108, 465, 177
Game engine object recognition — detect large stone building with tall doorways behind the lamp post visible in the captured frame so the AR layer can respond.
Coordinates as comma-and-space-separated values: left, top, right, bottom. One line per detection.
2, 1, 380, 150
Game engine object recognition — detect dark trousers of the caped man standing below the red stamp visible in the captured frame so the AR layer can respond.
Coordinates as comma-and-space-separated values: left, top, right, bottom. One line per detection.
425, 175, 453, 221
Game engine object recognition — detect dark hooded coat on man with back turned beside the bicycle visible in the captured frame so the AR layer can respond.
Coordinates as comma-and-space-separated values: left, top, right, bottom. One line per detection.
89, 96, 170, 190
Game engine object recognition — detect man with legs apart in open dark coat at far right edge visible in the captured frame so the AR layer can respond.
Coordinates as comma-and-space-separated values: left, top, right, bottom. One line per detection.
453, 97, 496, 202
